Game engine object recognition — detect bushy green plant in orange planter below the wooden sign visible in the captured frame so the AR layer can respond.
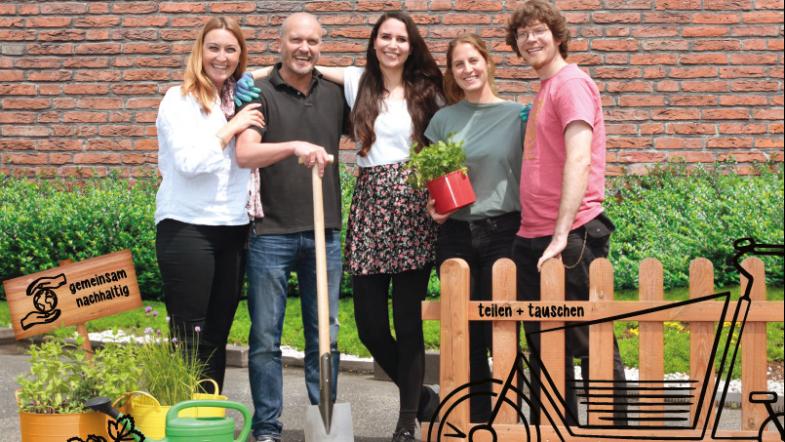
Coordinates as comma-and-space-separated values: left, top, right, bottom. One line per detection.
17, 336, 140, 442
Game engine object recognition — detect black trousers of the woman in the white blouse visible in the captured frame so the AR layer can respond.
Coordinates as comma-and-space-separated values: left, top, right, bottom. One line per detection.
155, 219, 248, 387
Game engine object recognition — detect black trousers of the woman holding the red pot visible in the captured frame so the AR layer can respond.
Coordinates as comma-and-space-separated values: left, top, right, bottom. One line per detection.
436, 212, 521, 422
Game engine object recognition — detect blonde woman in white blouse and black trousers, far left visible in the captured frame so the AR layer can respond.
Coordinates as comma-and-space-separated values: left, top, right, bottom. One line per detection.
155, 17, 264, 386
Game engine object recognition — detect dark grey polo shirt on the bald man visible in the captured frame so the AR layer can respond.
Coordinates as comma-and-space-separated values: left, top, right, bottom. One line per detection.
247, 63, 349, 235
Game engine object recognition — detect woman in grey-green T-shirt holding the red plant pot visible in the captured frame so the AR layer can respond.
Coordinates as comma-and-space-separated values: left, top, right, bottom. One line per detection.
425, 34, 528, 422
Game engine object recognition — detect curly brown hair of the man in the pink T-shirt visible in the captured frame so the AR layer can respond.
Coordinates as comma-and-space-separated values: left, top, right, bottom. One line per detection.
506, 0, 570, 60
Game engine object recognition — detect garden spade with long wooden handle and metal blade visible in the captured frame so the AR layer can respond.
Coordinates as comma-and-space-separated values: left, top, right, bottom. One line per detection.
304, 156, 354, 442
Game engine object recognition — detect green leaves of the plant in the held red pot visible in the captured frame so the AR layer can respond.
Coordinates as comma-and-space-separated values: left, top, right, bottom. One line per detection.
406, 136, 467, 188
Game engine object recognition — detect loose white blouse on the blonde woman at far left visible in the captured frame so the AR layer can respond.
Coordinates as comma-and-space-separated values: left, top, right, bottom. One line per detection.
155, 86, 251, 226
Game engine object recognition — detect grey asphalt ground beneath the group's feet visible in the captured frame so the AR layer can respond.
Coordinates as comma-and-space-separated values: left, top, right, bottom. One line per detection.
0, 344, 752, 442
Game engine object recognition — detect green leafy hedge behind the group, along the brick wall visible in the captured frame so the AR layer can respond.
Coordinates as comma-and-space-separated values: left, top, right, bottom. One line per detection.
0, 163, 783, 299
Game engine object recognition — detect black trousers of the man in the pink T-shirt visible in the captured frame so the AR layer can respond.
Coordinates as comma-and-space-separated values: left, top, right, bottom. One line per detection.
513, 214, 626, 425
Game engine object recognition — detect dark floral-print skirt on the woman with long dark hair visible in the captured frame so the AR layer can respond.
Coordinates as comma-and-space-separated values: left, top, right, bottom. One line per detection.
344, 163, 437, 275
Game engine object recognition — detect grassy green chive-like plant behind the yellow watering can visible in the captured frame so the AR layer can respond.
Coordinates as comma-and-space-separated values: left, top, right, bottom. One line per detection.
136, 307, 204, 405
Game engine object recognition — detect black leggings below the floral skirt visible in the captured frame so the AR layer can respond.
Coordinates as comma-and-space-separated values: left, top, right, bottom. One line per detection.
352, 265, 431, 418
